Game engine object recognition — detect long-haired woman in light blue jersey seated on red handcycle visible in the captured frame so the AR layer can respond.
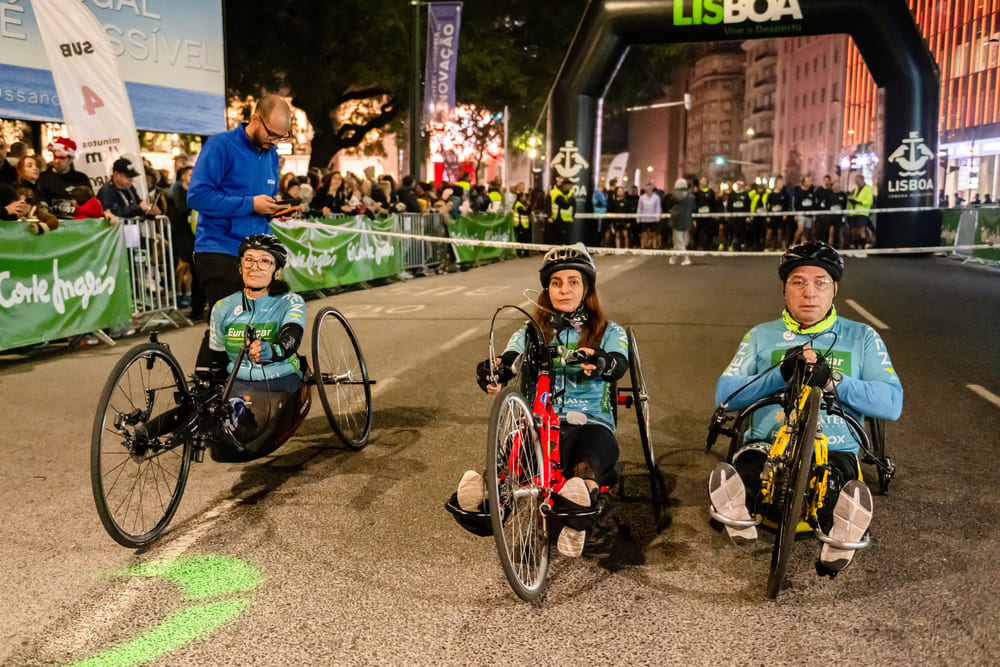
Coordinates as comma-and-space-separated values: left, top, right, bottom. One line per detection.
458, 243, 629, 557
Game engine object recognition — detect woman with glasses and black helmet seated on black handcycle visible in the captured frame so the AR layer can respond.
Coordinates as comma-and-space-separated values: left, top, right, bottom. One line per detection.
195, 234, 306, 458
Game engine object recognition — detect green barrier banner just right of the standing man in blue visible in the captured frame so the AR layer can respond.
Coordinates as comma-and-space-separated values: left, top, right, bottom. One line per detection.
271, 215, 402, 292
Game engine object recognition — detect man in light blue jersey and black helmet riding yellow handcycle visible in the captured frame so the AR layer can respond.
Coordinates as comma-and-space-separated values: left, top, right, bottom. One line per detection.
709, 242, 903, 576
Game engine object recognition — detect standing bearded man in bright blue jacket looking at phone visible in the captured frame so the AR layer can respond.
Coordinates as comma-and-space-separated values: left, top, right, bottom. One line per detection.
187, 95, 292, 317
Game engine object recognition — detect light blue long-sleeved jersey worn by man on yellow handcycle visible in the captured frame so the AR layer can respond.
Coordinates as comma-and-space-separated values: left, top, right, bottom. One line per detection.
715, 309, 903, 454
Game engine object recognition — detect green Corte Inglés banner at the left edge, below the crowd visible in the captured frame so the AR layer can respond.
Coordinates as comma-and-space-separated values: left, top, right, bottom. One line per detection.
0, 220, 132, 350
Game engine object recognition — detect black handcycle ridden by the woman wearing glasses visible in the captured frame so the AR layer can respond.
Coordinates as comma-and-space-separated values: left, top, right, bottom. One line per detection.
90, 307, 375, 548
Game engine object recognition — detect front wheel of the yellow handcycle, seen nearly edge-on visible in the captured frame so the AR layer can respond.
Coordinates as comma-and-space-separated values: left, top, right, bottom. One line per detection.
767, 390, 820, 600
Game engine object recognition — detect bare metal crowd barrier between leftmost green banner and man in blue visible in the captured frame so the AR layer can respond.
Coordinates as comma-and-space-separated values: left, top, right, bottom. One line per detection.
120, 215, 191, 330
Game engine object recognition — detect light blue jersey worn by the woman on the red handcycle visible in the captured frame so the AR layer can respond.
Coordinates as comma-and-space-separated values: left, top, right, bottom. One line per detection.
504, 322, 628, 433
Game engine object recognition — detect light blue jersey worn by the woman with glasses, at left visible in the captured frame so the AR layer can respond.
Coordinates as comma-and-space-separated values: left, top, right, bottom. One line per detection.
208, 292, 306, 381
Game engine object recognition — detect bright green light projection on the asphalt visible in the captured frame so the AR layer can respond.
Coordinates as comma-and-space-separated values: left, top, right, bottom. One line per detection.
72, 555, 263, 667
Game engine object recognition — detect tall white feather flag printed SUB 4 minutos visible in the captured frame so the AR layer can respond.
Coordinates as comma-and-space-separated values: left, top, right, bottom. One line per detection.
31, 0, 146, 200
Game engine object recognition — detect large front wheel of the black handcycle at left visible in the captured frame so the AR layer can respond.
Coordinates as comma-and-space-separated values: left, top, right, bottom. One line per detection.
90, 343, 194, 548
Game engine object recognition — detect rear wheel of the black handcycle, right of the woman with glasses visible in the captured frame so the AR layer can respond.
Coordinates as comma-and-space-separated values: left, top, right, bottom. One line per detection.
312, 306, 372, 450
